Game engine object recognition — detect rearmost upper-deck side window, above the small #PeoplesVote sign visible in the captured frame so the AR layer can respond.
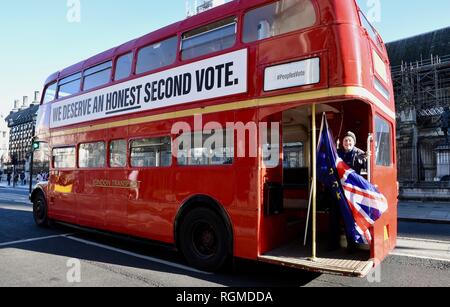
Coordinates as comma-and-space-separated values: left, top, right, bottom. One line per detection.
243, 0, 317, 43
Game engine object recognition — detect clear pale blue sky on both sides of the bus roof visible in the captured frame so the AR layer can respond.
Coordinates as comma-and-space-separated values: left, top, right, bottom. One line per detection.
0, 0, 450, 115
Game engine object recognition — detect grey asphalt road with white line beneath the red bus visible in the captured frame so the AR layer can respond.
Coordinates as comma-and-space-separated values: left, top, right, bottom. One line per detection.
0, 188, 450, 288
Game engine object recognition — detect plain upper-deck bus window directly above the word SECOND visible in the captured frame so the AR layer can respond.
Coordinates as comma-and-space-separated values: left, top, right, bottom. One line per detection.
136, 36, 178, 74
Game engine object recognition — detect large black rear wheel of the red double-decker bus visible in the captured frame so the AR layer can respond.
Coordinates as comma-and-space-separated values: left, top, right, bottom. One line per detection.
179, 208, 230, 272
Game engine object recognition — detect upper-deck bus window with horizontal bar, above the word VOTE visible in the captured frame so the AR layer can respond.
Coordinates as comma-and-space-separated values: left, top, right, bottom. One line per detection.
181, 17, 237, 60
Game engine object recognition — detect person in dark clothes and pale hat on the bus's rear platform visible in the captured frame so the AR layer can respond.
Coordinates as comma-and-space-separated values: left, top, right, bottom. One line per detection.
329, 131, 367, 253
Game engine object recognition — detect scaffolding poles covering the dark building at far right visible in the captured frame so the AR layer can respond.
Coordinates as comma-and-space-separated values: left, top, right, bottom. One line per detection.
392, 55, 450, 184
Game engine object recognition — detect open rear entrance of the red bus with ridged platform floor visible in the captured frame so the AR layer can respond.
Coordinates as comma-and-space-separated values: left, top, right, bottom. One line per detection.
259, 101, 374, 277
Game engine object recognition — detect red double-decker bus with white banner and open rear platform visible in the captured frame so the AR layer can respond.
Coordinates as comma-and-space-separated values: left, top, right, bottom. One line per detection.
31, 0, 398, 276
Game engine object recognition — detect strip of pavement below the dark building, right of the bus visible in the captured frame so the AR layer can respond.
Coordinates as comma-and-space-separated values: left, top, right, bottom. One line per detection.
398, 202, 450, 224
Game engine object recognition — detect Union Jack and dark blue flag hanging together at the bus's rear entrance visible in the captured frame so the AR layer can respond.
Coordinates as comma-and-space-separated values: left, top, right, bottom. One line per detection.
317, 114, 388, 244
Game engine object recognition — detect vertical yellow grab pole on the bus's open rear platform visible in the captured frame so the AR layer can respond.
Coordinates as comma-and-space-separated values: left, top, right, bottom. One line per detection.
312, 104, 317, 261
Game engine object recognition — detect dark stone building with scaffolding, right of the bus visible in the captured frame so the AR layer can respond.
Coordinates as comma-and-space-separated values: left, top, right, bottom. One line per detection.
387, 27, 450, 200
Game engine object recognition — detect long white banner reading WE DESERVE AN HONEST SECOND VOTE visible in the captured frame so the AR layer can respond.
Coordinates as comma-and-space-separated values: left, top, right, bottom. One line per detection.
50, 49, 247, 128
